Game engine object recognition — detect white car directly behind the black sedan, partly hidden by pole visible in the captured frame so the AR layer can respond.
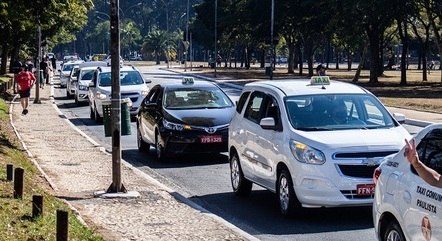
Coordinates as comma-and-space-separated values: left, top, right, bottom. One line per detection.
88, 66, 151, 122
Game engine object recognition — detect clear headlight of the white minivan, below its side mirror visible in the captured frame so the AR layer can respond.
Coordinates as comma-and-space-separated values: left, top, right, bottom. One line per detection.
290, 140, 325, 165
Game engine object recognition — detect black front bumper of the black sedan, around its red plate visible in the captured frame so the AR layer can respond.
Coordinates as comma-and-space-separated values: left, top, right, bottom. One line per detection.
160, 128, 228, 154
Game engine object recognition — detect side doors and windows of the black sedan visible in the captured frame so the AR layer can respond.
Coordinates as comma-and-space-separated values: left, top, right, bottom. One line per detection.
140, 85, 162, 143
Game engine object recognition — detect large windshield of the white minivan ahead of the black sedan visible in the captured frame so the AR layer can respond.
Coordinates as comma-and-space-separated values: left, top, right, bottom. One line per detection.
285, 94, 398, 131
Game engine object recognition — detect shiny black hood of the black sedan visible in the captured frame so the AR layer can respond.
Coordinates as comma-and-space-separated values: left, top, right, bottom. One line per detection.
164, 107, 235, 126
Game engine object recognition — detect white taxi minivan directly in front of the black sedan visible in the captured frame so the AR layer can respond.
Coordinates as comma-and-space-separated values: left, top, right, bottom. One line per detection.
229, 76, 410, 216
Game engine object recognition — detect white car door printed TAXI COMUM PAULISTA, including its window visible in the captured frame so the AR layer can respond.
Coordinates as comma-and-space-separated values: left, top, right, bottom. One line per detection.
402, 129, 442, 240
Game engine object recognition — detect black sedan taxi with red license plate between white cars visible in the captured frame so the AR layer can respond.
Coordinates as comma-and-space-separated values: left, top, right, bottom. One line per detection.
137, 78, 235, 161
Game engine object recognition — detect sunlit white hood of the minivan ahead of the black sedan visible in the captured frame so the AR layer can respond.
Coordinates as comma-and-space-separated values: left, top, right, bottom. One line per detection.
300, 126, 411, 151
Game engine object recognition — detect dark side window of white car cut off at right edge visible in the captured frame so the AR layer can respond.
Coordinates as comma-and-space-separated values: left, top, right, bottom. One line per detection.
412, 129, 442, 174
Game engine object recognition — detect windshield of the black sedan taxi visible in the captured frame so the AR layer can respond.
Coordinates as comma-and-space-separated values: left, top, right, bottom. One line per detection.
164, 86, 233, 109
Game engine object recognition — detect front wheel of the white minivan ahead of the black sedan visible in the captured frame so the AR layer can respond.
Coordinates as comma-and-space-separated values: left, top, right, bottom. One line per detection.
276, 169, 301, 217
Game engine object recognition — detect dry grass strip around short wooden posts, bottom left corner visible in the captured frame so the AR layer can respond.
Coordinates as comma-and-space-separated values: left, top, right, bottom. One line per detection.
0, 99, 103, 241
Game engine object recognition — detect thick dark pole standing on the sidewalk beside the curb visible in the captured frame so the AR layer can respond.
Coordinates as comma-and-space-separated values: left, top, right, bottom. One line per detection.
107, 0, 126, 193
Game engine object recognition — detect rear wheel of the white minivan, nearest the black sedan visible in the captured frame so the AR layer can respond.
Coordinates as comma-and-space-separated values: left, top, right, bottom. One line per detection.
230, 152, 253, 197
